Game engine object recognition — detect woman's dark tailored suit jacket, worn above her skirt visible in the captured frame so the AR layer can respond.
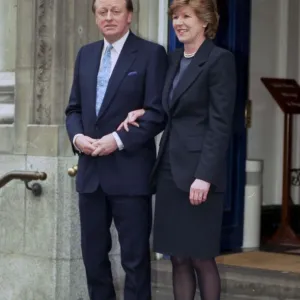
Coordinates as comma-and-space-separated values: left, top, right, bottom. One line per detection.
154, 39, 236, 192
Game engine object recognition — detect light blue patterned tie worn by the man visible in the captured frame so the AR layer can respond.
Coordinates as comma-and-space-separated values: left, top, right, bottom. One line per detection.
96, 45, 113, 116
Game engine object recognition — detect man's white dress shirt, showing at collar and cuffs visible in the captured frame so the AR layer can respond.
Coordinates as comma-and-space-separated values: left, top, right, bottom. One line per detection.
73, 31, 129, 151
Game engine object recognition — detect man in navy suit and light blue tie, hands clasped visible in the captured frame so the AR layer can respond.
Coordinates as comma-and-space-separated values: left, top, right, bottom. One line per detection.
66, 0, 167, 300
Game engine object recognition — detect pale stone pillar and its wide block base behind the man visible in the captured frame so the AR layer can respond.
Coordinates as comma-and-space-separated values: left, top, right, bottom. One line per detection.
0, 0, 158, 300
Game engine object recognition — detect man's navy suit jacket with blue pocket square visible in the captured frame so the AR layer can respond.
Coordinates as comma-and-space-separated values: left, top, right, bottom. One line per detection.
66, 33, 168, 196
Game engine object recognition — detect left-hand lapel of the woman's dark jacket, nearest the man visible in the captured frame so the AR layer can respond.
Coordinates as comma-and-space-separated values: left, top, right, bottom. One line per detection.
162, 49, 183, 113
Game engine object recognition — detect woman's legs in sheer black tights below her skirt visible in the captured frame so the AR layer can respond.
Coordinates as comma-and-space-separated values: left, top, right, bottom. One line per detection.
171, 256, 221, 300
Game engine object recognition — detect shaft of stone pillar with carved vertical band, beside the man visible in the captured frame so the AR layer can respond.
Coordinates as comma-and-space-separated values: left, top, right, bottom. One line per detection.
32, 0, 99, 125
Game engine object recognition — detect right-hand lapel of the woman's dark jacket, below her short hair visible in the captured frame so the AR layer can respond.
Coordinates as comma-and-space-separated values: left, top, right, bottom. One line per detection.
170, 39, 214, 109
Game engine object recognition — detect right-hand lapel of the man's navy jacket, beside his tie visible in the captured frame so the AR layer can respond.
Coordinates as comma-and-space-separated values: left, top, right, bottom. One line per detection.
98, 33, 137, 119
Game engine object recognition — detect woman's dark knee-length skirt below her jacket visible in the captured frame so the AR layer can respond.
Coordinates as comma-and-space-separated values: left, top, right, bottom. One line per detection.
153, 151, 224, 259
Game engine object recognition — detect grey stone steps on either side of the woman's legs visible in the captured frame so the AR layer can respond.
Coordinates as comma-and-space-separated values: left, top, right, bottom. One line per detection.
152, 260, 300, 300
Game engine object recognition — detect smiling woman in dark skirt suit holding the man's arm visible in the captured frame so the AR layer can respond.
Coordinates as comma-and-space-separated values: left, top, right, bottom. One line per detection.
118, 0, 236, 300
